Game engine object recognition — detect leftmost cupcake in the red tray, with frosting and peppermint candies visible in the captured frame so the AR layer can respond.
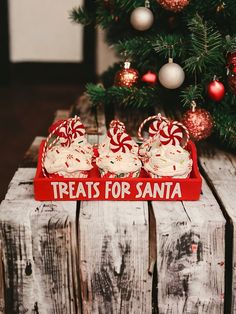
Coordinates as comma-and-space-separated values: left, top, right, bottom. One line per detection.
42, 116, 93, 178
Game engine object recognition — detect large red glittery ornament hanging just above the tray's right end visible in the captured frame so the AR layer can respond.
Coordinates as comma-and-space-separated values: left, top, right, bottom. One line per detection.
181, 108, 214, 142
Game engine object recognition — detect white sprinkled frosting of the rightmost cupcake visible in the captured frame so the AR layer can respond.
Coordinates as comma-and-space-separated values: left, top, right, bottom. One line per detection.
144, 145, 193, 178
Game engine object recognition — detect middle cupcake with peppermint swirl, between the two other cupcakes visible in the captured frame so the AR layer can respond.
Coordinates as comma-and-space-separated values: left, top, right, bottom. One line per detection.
96, 124, 142, 178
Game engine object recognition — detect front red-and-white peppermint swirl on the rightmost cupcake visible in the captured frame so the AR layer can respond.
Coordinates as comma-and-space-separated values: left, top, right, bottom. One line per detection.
160, 122, 184, 146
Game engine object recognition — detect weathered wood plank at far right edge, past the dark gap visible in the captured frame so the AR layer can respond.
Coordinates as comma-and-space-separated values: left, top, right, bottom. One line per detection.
200, 148, 236, 313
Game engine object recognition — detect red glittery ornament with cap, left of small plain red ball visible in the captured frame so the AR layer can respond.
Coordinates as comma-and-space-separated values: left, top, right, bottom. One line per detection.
114, 61, 139, 87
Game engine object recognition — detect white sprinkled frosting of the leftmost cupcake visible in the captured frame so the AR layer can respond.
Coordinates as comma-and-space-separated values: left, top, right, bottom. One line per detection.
44, 145, 93, 177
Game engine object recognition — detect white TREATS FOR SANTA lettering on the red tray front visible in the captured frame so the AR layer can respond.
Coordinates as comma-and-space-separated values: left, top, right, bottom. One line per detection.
51, 181, 182, 200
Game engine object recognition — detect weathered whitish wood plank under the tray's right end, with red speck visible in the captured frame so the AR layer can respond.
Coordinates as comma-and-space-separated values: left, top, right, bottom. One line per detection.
152, 178, 225, 314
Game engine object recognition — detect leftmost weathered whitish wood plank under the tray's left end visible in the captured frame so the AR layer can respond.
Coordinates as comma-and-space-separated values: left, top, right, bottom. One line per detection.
0, 168, 81, 314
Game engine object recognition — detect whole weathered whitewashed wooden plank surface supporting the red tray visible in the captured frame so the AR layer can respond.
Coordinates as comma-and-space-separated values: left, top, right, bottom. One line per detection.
0, 109, 236, 314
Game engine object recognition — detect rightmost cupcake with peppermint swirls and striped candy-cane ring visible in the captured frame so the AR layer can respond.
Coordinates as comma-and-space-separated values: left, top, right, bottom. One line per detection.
139, 114, 193, 178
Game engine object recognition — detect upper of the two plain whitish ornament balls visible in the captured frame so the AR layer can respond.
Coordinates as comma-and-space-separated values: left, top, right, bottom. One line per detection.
130, 7, 154, 31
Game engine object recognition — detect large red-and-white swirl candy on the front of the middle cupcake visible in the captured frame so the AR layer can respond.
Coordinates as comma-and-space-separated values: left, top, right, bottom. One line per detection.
110, 133, 133, 153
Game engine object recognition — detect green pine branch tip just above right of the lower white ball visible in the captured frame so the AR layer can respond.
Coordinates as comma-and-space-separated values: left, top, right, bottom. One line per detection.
185, 15, 224, 74
